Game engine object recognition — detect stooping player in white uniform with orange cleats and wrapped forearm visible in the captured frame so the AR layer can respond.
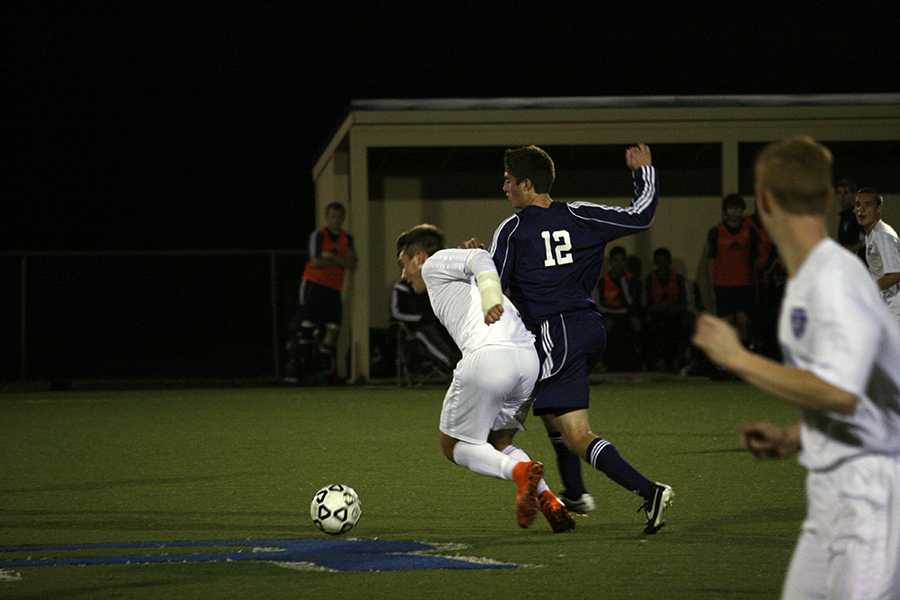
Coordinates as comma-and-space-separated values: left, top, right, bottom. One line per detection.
397, 224, 575, 533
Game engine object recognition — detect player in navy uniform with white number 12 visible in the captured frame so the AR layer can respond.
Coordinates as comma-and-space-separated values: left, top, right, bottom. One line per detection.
482, 144, 674, 533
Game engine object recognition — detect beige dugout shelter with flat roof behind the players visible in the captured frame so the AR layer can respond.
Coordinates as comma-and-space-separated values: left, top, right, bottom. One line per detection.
312, 94, 900, 381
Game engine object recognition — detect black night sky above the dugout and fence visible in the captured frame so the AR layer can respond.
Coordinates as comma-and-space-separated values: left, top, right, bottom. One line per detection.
7, 3, 900, 249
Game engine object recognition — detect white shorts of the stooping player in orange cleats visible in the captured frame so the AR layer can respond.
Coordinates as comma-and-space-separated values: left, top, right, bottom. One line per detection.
440, 346, 540, 444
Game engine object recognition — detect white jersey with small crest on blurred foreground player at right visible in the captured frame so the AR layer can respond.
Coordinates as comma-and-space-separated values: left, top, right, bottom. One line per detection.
778, 239, 900, 470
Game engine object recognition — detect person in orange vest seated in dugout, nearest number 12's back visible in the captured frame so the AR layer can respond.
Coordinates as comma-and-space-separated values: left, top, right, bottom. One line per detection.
597, 246, 641, 371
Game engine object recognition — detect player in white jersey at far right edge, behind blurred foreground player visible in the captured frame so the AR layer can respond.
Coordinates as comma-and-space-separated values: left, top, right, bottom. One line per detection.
856, 188, 900, 322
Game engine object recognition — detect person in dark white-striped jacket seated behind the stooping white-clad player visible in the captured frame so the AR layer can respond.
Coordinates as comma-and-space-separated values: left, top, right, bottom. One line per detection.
391, 279, 462, 374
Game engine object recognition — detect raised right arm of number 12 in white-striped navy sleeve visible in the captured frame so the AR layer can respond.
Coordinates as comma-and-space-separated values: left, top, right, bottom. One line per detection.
568, 144, 659, 237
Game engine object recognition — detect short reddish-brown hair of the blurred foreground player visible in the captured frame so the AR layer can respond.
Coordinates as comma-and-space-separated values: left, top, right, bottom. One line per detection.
755, 135, 834, 215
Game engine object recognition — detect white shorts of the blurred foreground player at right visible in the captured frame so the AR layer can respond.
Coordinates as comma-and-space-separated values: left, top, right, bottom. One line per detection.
782, 455, 900, 600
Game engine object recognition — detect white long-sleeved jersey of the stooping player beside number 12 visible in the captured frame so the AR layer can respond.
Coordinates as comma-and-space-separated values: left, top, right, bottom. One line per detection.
422, 248, 534, 355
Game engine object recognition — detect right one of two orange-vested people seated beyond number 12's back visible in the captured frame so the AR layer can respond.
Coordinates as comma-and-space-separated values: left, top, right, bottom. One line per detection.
644, 248, 689, 371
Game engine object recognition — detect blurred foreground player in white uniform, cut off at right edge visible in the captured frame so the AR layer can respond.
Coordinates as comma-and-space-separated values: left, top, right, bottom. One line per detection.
693, 137, 900, 600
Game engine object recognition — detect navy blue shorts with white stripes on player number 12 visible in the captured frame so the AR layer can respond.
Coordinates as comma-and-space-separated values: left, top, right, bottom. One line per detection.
532, 310, 606, 415
